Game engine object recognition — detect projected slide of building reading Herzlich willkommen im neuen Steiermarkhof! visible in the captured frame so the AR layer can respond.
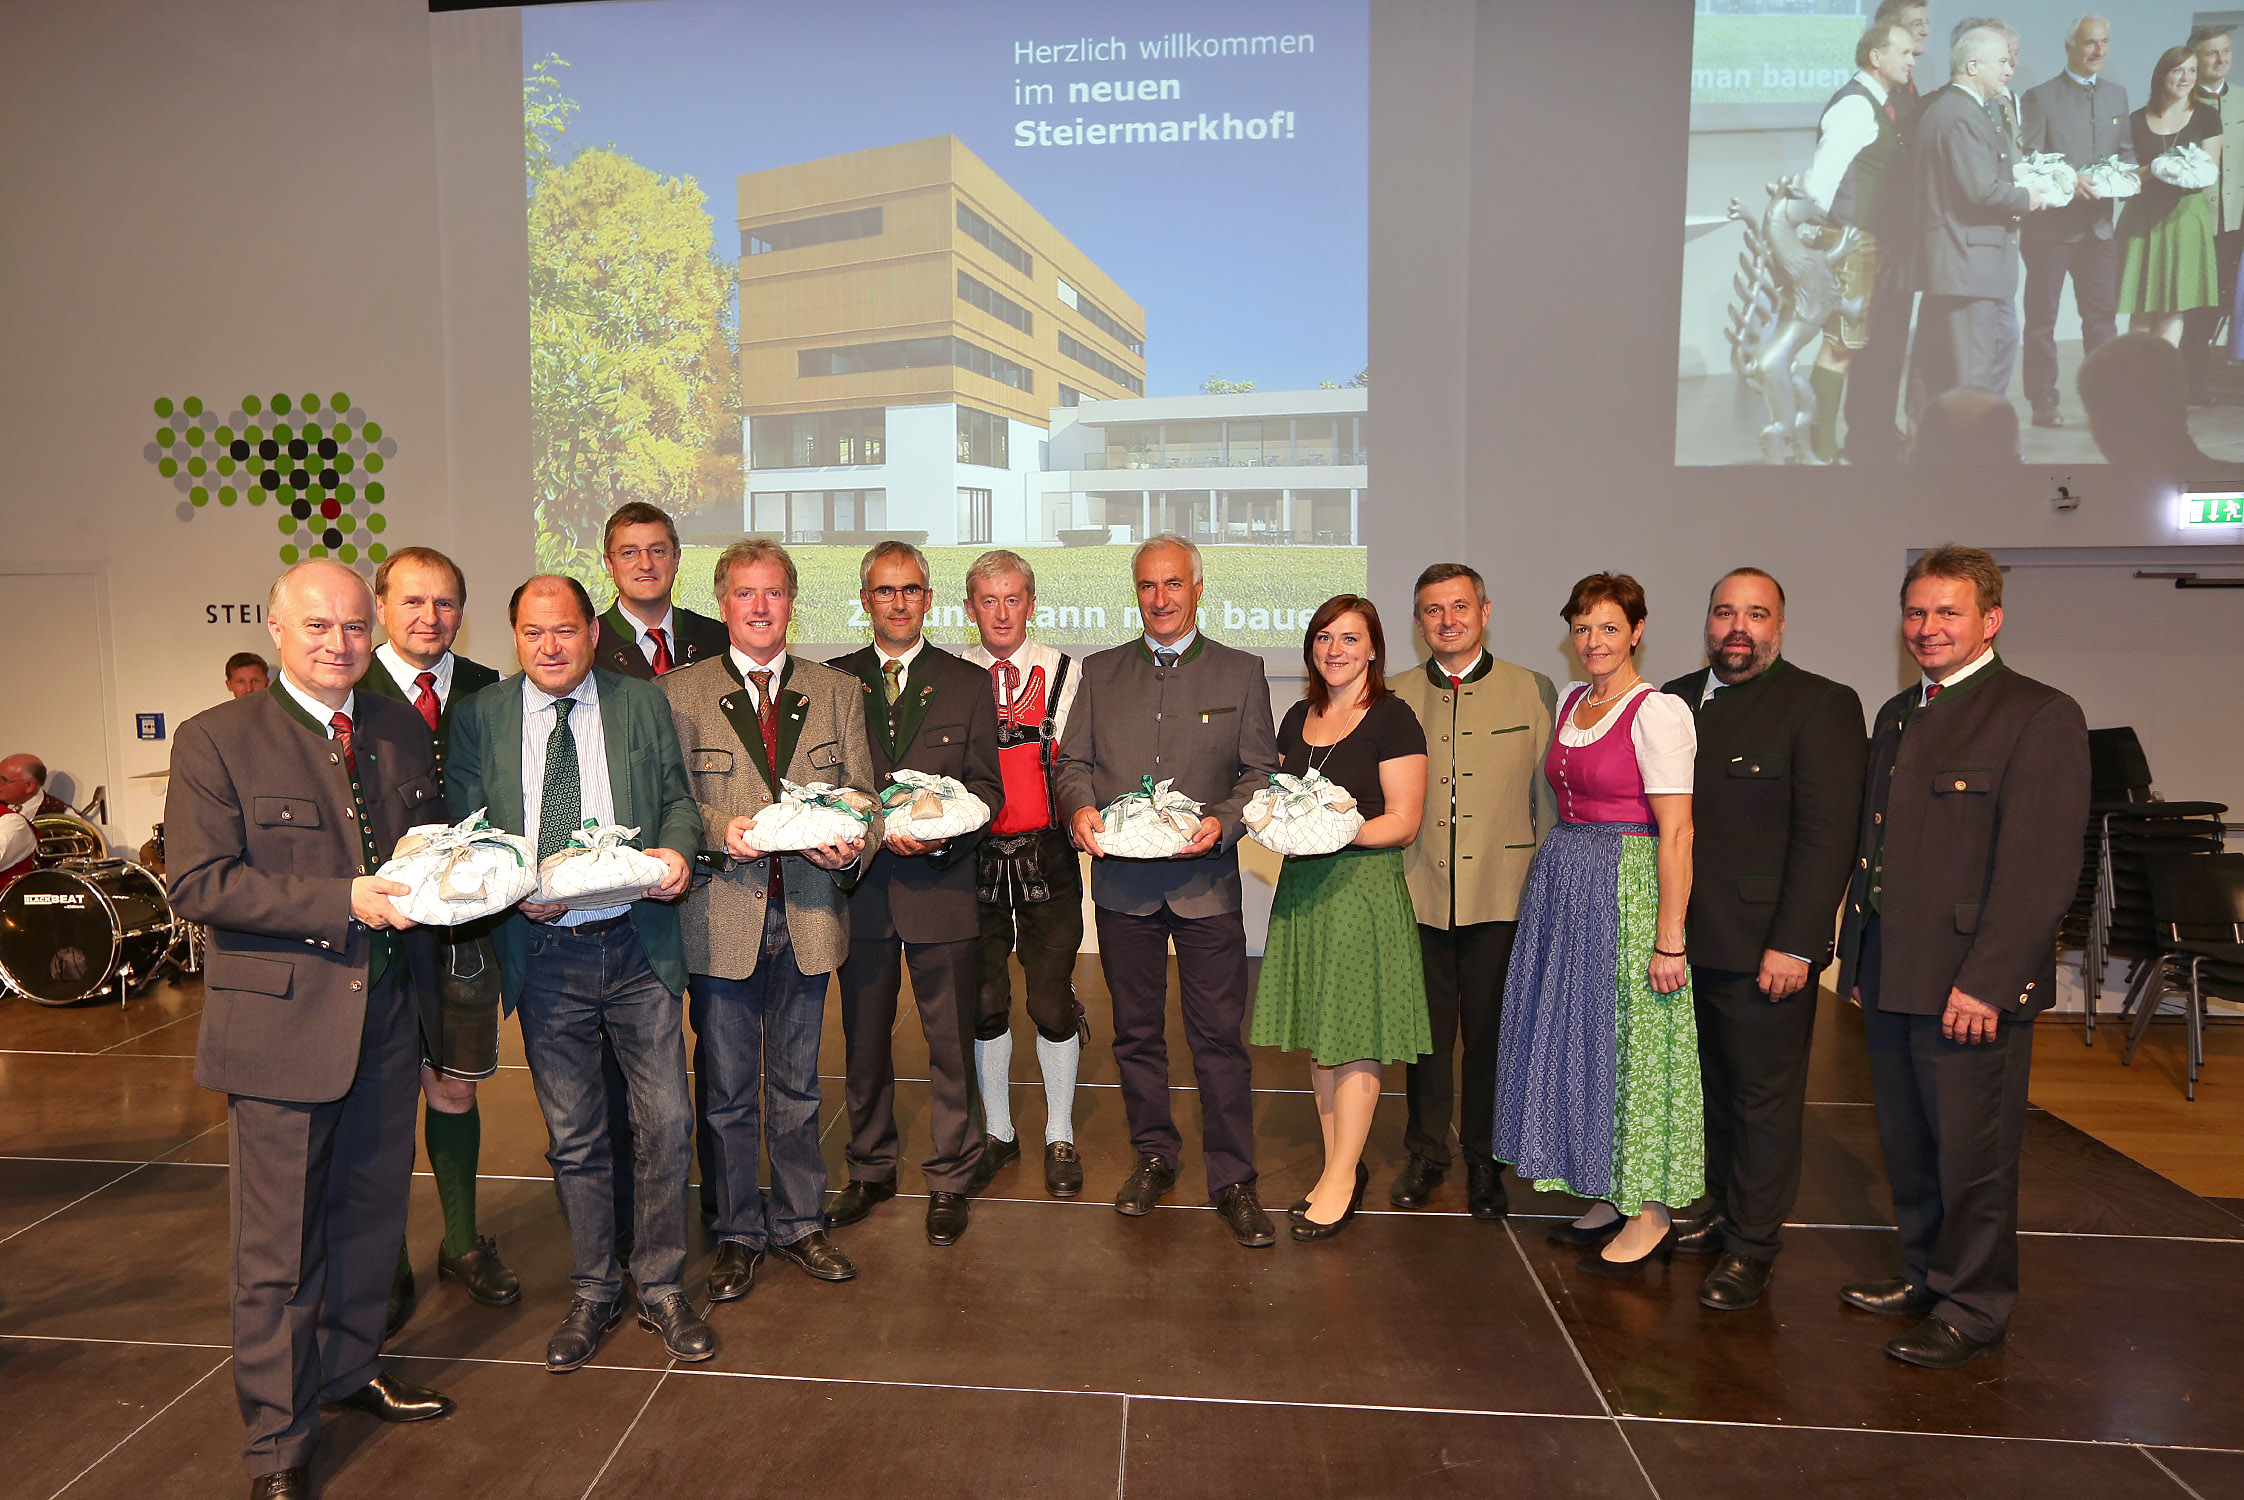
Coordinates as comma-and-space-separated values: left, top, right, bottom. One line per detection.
523, 0, 1371, 647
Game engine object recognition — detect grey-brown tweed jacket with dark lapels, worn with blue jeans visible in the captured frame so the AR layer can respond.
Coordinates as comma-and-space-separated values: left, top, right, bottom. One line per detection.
655, 656, 880, 979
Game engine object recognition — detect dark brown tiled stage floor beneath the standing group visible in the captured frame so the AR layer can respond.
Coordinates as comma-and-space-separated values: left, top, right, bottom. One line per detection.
0, 961, 2244, 1500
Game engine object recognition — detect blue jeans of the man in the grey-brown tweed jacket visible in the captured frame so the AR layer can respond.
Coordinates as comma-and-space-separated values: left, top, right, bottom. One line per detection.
687, 900, 828, 1251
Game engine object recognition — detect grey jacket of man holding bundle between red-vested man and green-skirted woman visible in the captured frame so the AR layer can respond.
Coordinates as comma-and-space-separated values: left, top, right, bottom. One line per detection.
1055, 633, 1279, 916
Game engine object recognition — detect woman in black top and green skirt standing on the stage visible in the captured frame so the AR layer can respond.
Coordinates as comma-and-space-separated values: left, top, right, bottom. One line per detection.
1248, 593, 1434, 1242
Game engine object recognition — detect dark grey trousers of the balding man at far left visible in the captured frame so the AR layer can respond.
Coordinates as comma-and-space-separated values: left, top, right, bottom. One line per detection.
227, 966, 420, 1478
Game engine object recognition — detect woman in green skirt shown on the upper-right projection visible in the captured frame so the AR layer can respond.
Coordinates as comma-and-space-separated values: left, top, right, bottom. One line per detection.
2116, 47, 2222, 346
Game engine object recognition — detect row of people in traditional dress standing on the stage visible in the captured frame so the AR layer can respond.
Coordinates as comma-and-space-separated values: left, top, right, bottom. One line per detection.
166, 505, 2087, 1496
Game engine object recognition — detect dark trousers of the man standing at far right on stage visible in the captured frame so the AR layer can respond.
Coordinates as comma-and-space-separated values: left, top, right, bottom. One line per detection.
1863, 923, 2033, 1341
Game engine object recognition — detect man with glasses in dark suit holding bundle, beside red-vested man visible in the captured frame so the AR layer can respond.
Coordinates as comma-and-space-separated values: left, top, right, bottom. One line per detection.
826, 541, 1005, 1244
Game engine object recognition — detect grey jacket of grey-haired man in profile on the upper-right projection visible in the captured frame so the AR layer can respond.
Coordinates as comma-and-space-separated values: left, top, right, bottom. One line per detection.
1910, 83, 2033, 301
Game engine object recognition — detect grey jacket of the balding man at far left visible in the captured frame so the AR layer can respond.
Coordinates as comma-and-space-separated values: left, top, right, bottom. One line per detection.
164, 682, 444, 1103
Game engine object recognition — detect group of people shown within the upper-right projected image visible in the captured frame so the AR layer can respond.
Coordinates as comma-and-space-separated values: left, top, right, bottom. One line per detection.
1797, 0, 2244, 463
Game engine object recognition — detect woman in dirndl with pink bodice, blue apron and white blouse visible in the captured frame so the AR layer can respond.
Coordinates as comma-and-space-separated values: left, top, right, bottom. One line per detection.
1495, 573, 1705, 1275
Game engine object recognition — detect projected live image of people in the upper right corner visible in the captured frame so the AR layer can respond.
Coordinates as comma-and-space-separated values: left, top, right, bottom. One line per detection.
1676, 0, 2244, 465
